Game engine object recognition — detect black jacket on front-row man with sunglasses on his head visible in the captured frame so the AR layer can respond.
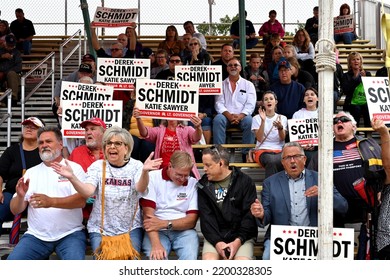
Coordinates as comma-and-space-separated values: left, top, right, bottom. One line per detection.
197, 168, 257, 246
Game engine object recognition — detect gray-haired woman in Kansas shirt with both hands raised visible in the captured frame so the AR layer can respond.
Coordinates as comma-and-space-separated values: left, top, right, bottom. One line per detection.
53, 126, 162, 258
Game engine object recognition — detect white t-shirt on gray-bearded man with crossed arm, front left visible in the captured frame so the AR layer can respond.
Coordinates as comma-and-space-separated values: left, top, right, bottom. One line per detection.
24, 160, 85, 241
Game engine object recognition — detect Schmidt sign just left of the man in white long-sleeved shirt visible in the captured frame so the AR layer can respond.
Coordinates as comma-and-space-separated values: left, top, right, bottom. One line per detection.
175, 65, 223, 95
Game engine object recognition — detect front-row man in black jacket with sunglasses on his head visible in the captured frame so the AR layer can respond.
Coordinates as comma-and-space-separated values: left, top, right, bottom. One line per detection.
197, 145, 257, 260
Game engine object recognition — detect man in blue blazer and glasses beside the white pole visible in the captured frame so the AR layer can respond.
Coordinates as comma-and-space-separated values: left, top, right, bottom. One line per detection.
251, 142, 348, 260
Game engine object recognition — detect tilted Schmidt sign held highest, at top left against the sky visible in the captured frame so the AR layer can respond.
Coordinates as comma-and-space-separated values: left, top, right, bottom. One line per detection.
91, 7, 138, 27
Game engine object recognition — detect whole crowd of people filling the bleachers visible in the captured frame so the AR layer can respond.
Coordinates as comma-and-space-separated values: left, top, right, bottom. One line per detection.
0, 4, 390, 260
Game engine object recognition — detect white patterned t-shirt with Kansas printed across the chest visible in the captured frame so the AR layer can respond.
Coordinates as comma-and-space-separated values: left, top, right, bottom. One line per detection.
85, 158, 143, 236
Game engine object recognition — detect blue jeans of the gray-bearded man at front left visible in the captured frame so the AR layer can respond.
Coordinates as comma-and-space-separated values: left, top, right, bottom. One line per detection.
8, 230, 87, 260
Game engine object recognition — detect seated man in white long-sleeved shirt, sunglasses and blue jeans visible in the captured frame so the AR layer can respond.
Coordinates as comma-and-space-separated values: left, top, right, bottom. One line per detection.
213, 58, 256, 162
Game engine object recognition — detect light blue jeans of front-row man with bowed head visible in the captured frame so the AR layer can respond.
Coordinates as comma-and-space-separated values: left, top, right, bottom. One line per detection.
142, 229, 199, 260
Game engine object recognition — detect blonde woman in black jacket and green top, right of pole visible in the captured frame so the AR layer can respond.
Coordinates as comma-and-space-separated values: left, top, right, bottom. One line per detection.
341, 52, 371, 127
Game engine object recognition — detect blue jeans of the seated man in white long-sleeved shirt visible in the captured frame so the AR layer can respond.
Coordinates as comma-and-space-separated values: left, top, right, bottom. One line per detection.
213, 114, 255, 155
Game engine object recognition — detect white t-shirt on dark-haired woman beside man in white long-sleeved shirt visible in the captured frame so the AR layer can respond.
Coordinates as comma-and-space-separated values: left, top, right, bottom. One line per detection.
252, 114, 287, 150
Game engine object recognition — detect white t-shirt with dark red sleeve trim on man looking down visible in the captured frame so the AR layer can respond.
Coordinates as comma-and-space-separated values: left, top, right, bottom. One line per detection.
143, 169, 198, 220
